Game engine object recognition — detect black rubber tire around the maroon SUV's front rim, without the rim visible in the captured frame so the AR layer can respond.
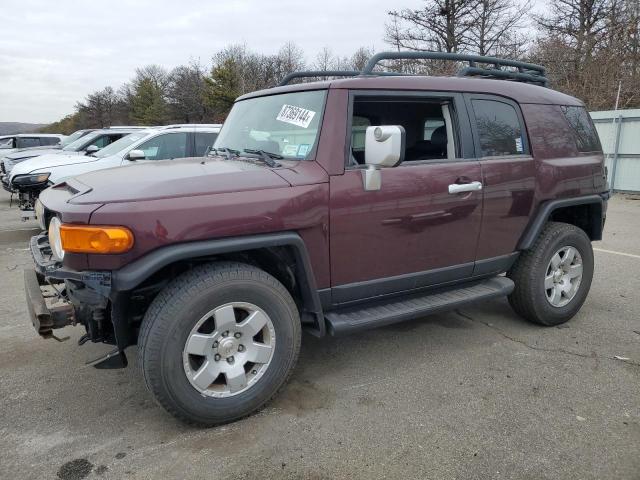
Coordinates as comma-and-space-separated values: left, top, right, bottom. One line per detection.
138, 262, 301, 427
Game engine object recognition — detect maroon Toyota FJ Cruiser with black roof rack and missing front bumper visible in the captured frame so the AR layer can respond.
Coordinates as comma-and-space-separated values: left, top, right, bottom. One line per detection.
25, 52, 608, 425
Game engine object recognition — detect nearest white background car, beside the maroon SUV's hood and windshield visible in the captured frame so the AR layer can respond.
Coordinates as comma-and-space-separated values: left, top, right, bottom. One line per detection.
5, 124, 222, 210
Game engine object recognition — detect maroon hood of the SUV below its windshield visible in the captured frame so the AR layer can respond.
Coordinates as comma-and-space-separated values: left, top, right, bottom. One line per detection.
68, 158, 291, 204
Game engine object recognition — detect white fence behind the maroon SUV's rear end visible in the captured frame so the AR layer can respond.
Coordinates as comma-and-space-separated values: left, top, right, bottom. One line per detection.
591, 109, 640, 192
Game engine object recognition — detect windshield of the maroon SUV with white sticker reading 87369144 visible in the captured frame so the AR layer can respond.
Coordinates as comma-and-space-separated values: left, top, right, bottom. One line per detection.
214, 90, 326, 160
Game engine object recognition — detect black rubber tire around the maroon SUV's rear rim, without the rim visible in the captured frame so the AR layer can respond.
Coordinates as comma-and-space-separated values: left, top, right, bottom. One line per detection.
507, 222, 593, 326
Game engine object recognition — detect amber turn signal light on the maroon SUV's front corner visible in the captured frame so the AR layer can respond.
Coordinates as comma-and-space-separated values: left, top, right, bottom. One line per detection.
60, 224, 133, 253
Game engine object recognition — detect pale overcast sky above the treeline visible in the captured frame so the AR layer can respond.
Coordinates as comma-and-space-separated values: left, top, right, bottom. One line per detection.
0, 0, 436, 123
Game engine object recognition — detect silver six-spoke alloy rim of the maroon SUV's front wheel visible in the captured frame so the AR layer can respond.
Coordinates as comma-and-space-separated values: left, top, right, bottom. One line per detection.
182, 302, 276, 398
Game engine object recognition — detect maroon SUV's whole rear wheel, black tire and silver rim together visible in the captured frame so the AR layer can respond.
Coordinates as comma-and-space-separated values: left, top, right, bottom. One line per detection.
508, 222, 593, 326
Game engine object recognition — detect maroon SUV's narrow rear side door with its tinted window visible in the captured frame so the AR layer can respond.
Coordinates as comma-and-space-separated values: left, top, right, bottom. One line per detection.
465, 94, 536, 274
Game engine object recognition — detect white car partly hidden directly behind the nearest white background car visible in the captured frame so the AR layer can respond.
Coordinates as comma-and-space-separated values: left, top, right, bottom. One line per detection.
0, 126, 144, 175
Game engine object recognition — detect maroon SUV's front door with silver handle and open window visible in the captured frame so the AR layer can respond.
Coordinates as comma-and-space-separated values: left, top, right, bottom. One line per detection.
330, 93, 482, 304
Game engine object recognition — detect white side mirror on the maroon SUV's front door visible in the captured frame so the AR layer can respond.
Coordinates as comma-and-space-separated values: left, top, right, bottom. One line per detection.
362, 125, 406, 191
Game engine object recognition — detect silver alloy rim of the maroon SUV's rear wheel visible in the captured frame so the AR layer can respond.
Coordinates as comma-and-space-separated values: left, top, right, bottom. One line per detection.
544, 246, 583, 307
